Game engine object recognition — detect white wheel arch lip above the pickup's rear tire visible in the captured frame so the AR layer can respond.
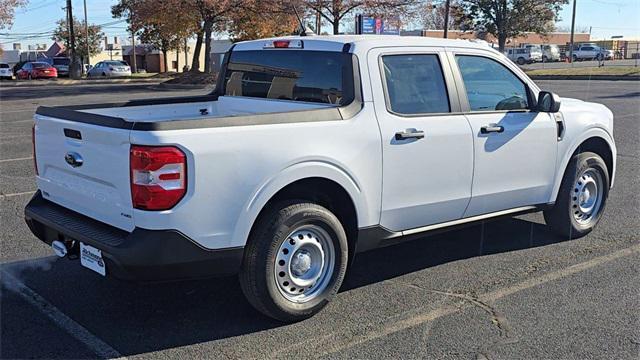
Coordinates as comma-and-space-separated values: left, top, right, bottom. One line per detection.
231, 160, 372, 246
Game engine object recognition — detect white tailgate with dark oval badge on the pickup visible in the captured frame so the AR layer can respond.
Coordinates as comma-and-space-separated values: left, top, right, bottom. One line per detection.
35, 115, 135, 231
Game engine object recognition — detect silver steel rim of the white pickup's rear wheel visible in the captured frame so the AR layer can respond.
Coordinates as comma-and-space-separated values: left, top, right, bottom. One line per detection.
274, 225, 336, 303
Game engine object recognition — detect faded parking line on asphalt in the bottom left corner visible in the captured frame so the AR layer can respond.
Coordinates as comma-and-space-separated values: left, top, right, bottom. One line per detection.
0, 270, 126, 359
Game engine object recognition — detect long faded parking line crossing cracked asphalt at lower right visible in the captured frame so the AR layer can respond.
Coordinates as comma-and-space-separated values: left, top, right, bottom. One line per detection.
314, 244, 640, 357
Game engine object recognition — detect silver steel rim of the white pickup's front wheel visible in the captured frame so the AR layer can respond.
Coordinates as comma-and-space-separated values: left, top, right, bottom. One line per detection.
571, 168, 604, 225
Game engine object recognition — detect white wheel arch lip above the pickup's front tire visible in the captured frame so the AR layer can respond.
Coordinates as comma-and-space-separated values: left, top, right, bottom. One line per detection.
551, 128, 616, 201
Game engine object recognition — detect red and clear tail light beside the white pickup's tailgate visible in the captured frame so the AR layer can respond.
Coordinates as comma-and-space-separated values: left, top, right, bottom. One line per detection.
129, 145, 187, 210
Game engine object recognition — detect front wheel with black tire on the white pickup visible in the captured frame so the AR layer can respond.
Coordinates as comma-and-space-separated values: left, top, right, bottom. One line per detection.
544, 152, 610, 239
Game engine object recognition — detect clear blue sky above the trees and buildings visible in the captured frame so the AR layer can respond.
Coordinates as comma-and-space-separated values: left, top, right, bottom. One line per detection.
0, 0, 640, 49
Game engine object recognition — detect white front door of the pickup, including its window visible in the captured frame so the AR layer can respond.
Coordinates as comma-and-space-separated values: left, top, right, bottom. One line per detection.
454, 50, 558, 217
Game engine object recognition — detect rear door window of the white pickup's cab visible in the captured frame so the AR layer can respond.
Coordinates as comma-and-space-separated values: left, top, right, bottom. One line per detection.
382, 54, 450, 115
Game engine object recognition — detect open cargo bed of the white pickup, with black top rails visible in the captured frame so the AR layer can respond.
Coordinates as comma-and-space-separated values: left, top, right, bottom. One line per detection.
36, 95, 361, 131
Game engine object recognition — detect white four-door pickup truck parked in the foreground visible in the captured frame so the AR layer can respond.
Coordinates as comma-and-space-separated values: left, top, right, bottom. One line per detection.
25, 35, 616, 321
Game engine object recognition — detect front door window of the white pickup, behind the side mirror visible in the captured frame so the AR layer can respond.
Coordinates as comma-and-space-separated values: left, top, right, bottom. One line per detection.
456, 55, 529, 111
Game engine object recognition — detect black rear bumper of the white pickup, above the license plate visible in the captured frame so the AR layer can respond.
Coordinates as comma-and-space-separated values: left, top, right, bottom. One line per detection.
25, 191, 244, 281
